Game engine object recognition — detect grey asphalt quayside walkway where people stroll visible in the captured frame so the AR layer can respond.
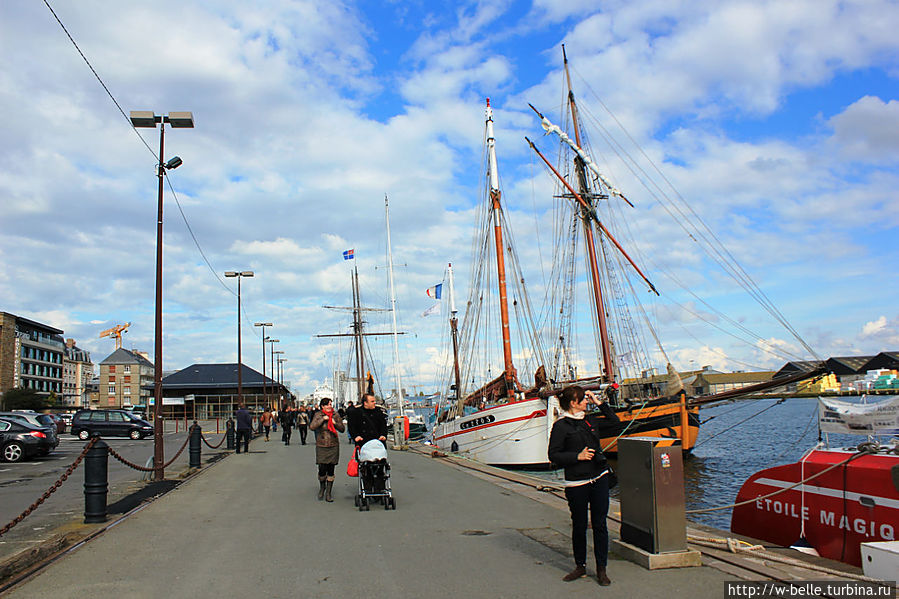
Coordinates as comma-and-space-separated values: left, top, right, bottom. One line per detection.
8, 434, 734, 599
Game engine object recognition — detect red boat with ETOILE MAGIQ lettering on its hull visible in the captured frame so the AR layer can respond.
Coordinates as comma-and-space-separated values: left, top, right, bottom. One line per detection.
730, 443, 899, 566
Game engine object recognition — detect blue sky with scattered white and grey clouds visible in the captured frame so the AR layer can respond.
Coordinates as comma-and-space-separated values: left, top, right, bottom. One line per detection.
0, 0, 899, 395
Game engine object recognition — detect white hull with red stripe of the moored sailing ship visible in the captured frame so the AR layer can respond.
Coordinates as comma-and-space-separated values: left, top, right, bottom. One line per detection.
433, 398, 558, 467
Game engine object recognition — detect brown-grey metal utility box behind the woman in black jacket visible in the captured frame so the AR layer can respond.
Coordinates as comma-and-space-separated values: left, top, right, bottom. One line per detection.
618, 437, 687, 553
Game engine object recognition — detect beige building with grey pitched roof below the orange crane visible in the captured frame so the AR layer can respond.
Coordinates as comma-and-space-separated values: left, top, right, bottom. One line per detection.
99, 347, 154, 409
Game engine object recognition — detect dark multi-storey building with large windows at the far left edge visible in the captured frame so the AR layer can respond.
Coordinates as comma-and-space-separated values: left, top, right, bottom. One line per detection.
0, 312, 65, 397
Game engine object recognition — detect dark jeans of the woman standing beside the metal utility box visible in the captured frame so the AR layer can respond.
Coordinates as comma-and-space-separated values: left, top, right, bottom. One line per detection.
565, 474, 609, 568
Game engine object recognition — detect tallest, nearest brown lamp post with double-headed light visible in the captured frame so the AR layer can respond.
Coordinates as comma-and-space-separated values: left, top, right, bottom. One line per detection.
131, 110, 194, 480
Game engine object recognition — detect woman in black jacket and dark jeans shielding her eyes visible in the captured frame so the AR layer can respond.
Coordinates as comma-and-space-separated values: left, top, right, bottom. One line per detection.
548, 386, 618, 586
